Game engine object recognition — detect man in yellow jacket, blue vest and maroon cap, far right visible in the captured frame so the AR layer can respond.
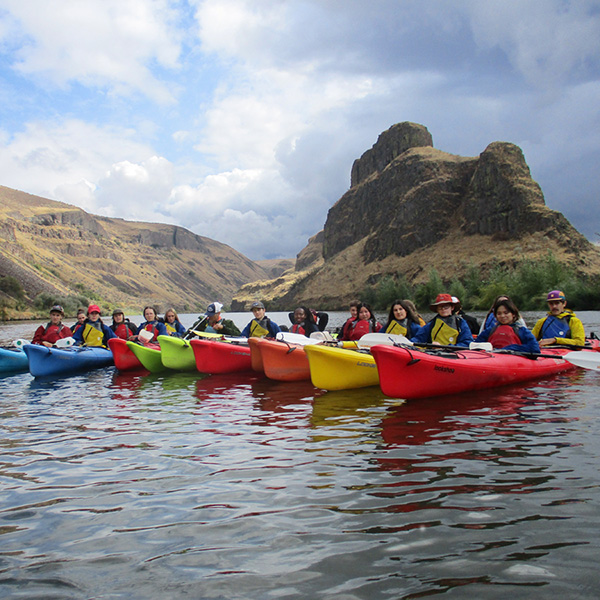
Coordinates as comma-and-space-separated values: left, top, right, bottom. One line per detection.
532, 290, 585, 346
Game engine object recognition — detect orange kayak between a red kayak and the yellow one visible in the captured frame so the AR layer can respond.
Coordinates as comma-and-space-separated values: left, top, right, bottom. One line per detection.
250, 338, 310, 381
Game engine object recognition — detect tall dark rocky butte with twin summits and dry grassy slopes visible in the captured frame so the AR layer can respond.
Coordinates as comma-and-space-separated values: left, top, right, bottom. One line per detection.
232, 122, 600, 309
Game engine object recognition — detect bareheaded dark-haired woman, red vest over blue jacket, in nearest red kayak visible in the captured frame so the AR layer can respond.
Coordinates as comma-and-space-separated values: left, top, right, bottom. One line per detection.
475, 298, 540, 353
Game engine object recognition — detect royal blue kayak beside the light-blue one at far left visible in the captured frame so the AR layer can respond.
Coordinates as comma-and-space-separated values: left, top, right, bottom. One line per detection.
23, 344, 114, 377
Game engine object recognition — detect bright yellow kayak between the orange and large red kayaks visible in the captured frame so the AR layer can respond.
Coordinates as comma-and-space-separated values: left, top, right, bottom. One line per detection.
304, 346, 379, 390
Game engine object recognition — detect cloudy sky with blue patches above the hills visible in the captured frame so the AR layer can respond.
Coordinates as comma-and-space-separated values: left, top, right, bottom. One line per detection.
0, 0, 600, 260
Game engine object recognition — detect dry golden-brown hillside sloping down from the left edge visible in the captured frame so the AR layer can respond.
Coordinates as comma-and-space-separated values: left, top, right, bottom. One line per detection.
0, 187, 268, 317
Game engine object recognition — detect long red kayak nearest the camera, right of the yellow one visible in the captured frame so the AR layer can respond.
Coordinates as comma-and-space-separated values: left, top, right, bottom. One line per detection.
371, 346, 576, 399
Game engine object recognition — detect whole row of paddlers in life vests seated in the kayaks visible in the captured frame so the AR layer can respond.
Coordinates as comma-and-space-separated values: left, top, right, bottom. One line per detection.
32, 290, 585, 352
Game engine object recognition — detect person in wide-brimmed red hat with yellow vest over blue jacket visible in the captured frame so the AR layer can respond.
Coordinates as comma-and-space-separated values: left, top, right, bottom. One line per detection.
411, 294, 473, 347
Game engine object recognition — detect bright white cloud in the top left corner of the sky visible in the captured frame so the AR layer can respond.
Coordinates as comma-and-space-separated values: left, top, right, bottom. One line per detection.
2, 0, 181, 103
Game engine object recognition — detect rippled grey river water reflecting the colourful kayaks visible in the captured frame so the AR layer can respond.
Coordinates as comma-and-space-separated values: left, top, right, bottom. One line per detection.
0, 313, 600, 600
